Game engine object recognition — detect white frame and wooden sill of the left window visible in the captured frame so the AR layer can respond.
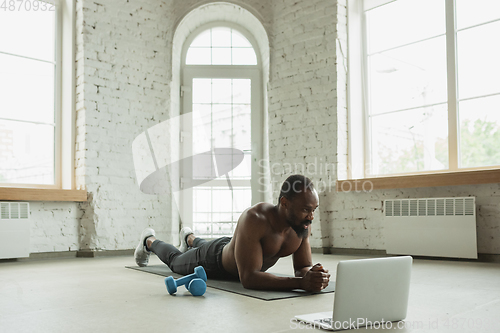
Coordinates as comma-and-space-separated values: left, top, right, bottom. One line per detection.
0, 0, 82, 201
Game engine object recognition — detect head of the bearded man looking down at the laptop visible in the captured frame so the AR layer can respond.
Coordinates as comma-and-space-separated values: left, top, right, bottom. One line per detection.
278, 175, 319, 238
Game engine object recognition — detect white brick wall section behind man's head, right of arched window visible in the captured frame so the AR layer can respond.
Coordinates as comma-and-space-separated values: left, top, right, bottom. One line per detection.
269, 0, 337, 247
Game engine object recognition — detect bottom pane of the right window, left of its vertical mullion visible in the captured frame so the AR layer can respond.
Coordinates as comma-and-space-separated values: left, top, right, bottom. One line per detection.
370, 104, 448, 174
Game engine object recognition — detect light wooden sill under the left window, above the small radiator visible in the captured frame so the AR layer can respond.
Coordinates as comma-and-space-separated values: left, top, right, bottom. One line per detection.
0, 187, 87, 202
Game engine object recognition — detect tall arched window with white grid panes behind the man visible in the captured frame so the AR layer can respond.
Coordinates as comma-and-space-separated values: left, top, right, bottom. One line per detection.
180, 23, 263, 238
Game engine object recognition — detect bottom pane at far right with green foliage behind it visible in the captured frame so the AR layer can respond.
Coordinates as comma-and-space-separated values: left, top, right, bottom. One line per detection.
459, 96, 500, 168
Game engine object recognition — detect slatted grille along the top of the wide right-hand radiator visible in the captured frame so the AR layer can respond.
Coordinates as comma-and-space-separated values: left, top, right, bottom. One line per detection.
384, 197, 476, 216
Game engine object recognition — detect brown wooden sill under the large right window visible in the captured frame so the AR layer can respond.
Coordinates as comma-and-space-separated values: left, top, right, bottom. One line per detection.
337, 169, 500, 192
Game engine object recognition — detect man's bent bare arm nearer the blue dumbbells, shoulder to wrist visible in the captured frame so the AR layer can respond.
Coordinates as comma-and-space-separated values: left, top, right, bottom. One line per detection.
234, 212, 302, 290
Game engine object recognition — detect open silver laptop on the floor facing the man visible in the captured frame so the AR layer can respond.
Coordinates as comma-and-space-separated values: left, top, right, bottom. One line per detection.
295, 256, 413, 330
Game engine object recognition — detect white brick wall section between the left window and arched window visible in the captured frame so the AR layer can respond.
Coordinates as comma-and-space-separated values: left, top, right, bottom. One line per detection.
73, 0, 173, 250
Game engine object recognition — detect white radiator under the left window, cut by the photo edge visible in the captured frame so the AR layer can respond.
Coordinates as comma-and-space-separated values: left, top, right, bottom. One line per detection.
0, 202, 30, 259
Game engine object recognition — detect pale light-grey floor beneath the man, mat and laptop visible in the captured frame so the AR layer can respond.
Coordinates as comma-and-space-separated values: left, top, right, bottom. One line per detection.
0, 254, 500, 333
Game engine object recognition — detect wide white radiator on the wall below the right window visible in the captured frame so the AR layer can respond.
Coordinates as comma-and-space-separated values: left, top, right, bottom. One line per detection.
384, 197, 477, 259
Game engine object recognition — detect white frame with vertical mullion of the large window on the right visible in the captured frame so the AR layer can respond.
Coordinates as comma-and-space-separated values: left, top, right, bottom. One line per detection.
346, 0, 500, 190
